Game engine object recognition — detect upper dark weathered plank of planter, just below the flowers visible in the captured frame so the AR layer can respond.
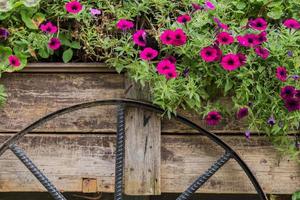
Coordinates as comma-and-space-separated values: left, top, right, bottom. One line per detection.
0, 69, 251, 134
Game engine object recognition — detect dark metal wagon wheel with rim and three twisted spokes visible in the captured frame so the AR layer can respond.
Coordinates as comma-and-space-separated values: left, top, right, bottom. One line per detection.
0, 99, 267, 200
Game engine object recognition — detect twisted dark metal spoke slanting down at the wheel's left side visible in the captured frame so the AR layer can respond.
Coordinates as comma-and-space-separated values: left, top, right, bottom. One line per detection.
9, 144, 66, 200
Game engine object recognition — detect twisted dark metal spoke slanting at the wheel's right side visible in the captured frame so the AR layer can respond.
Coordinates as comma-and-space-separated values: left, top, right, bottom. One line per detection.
176, 152, 232, 200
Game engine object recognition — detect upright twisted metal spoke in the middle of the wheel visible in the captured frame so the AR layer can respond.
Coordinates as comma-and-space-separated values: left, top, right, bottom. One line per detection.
114, 104, 125, 200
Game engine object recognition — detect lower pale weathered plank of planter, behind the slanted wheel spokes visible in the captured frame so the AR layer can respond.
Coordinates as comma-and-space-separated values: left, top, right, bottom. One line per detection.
0, 134, 300, 194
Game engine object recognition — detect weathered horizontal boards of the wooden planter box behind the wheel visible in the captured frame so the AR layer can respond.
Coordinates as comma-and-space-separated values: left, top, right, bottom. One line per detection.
0, 64, 300, 198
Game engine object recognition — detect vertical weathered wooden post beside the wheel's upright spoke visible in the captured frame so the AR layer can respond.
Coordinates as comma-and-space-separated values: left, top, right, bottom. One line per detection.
124, 78, 161, 196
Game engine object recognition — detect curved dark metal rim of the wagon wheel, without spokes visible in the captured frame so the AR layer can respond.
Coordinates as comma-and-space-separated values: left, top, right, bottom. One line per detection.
0, 99, 268, 200
